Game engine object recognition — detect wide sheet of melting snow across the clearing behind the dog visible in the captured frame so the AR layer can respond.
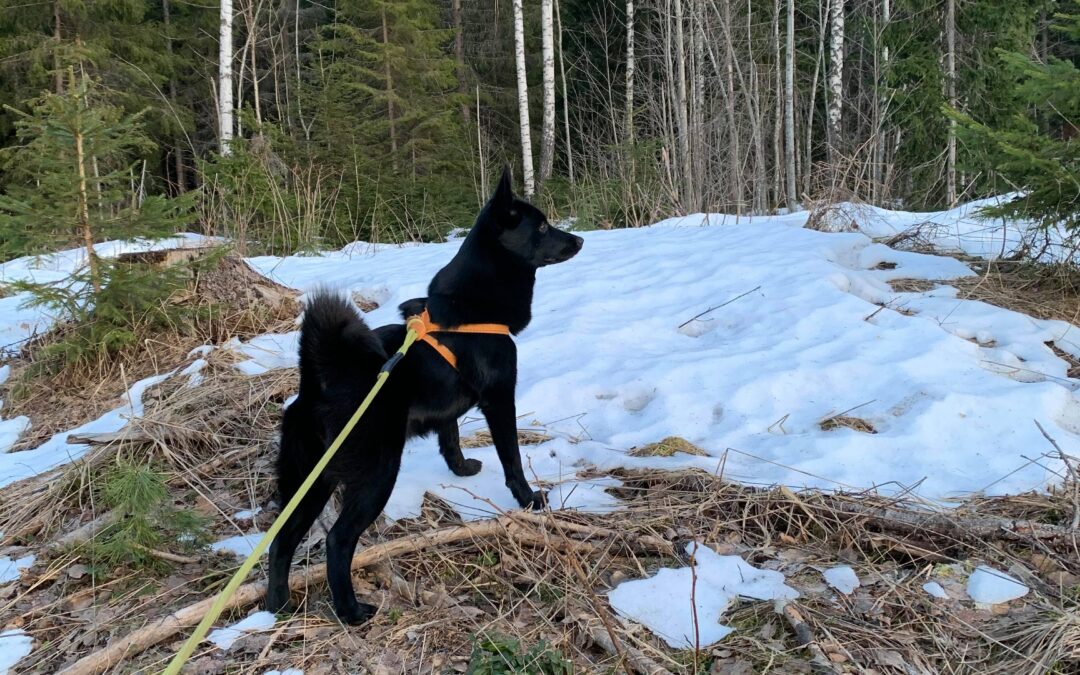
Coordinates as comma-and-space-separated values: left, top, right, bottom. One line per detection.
0, 198, 1080, 509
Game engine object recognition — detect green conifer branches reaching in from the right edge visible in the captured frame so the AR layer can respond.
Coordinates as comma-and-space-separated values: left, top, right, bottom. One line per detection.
947, 14, 1080, 231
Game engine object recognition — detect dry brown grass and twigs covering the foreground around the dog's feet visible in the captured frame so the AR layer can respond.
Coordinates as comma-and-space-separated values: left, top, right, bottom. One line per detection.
0, 360, 1080, 675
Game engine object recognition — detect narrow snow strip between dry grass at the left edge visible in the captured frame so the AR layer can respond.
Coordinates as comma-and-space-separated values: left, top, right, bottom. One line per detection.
0, 372, 173, 488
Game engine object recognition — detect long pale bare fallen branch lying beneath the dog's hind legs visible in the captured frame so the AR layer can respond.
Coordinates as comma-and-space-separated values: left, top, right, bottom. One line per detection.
60, 516, 626, 675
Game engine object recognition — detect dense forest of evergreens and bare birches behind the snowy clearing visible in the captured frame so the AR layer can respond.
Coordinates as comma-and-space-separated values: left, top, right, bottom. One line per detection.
0, 0, 1080, 260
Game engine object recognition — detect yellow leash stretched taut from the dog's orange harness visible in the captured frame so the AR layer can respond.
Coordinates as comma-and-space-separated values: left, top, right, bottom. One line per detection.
164, 318, 418, 675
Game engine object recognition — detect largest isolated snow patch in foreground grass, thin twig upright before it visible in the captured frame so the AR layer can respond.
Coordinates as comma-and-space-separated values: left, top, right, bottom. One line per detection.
608, 542, 798, 648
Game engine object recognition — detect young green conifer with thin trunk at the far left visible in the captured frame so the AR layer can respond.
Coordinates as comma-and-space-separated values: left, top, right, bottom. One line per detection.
0, 68, 190, 274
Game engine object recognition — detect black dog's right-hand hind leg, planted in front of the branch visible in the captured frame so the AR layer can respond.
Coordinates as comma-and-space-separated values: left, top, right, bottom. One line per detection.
326, 449, 405, 624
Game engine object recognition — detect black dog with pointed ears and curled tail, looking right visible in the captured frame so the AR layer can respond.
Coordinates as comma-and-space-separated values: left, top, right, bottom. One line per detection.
266, 171, 583, 623
